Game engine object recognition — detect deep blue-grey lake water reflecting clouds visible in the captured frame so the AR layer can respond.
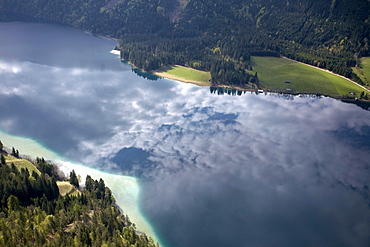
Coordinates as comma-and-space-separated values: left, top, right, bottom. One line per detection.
0, 23, 370, 247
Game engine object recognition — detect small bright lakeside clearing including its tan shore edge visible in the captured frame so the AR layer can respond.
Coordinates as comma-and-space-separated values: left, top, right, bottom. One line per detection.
154, 65, 211, 86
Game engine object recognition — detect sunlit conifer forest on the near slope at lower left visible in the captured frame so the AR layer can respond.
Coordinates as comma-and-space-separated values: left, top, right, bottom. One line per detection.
0, 142, 158, 247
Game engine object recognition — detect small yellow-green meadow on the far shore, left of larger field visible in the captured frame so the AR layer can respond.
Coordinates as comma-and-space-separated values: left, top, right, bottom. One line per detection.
156, 65, 211, 83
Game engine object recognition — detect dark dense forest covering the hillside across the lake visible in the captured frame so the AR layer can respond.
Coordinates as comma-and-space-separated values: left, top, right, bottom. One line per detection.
0, 0, 370, 87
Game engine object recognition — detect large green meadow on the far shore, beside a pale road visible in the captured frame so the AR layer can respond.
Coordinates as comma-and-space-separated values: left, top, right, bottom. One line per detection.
252, 57, 364, 97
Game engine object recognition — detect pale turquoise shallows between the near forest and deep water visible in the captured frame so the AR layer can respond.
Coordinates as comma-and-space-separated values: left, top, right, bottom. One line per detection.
0, 130, 161, 245
